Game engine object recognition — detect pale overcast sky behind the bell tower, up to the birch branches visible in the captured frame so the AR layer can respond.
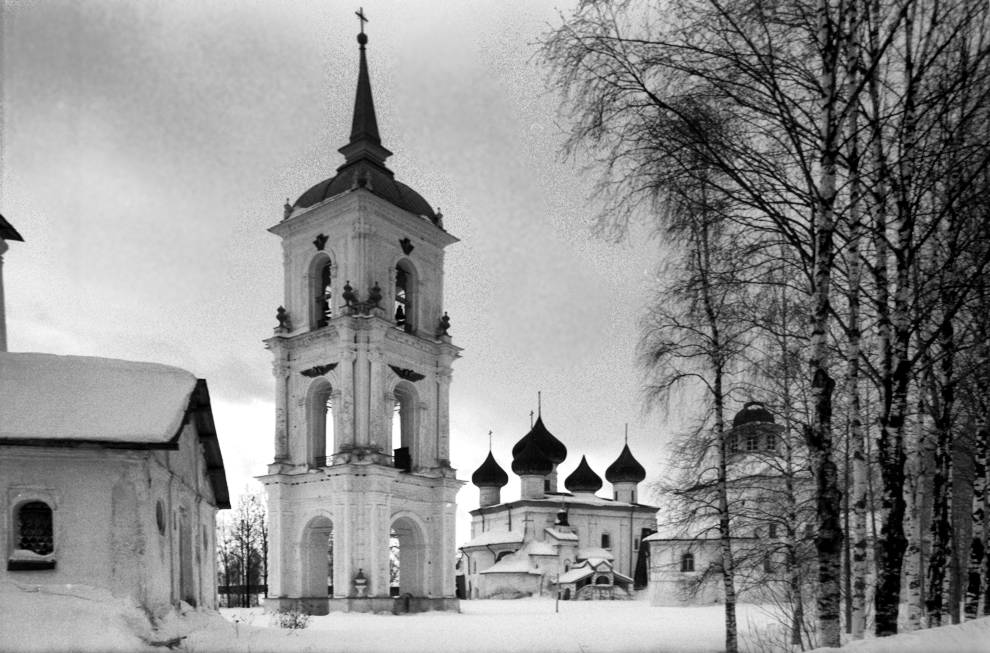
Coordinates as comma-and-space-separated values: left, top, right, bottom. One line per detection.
0, 0, 669, 541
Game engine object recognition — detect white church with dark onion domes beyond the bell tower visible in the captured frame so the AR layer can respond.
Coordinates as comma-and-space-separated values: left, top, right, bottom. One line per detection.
461, 417, 657, 599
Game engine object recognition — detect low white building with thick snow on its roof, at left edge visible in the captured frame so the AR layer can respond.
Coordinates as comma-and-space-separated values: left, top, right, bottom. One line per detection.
0, 353, 230, 615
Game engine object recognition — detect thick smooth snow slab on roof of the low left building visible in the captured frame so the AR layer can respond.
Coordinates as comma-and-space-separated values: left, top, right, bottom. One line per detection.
0, 352, 196, 444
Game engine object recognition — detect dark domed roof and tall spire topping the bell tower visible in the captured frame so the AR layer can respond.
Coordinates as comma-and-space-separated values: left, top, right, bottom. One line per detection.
293, 34, 440, 226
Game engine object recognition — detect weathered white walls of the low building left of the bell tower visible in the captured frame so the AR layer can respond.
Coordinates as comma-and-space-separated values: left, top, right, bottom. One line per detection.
0, 420, 222, 614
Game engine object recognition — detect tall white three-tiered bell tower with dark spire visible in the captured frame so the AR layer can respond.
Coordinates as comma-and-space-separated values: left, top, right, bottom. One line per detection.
259, 19, 462, 614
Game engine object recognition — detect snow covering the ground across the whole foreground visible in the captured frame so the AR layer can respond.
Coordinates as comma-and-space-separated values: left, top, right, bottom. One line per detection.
0, 583, 990, 653
